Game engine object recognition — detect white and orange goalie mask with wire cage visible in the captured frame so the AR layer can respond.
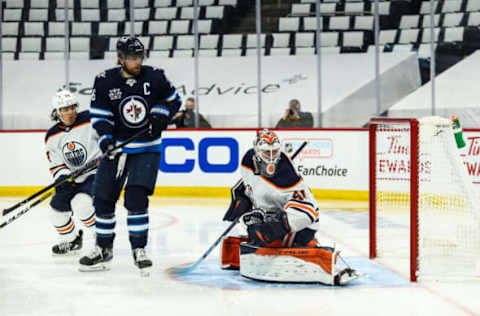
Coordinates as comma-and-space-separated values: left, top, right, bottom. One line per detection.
253, 129, 280, 178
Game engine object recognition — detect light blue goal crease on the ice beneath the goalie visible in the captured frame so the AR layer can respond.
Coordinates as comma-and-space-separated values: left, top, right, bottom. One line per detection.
170, 257, 412, 290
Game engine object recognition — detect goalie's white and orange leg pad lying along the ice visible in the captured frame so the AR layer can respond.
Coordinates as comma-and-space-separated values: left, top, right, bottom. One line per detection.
240, 243, 338, 285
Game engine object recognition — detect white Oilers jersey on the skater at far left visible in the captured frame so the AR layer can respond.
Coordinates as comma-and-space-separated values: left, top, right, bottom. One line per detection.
45, 111, 100, 183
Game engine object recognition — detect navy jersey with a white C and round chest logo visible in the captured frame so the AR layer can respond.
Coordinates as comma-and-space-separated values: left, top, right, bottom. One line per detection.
90, 65, 181, 154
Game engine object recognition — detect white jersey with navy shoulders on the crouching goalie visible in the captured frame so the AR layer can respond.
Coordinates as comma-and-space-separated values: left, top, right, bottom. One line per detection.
241, 149, 318, 232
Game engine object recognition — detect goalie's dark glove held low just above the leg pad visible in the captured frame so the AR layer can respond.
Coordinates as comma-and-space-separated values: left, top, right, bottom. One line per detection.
247, 213, 290, 246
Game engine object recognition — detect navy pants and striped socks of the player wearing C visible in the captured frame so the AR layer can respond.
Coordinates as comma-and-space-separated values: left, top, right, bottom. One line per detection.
93, 152, 160, 249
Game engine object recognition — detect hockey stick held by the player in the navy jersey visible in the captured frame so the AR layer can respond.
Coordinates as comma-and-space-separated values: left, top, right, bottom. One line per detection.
2, 129, 148, 216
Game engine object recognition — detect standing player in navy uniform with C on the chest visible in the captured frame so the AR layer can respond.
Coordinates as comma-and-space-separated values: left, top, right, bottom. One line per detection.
80, 37, 181, 274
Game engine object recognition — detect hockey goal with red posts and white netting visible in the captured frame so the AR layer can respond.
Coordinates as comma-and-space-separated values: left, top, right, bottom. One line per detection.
369, 117, 480, 281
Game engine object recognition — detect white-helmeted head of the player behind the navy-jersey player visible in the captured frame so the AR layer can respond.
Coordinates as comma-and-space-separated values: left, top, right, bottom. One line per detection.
50, 89, 79, 126
